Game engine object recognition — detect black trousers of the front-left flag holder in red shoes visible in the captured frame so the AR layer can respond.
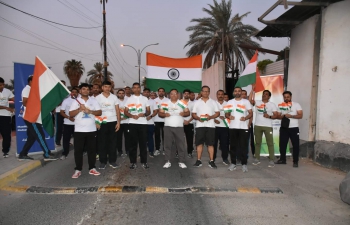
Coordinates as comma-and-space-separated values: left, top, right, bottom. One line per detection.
74, 131, 96, 171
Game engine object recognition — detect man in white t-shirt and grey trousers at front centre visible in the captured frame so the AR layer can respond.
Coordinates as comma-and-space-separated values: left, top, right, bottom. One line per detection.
158, 89, 190, 169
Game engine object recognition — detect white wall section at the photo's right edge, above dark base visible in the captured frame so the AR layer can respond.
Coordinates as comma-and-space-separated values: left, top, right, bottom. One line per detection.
316, 0, 350, 144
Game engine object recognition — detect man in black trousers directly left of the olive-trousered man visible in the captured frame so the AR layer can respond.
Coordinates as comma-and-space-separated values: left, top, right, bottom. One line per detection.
225, 87, 253, 172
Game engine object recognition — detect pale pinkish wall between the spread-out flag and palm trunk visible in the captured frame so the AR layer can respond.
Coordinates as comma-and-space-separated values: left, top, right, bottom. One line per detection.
202, 61, 225, 100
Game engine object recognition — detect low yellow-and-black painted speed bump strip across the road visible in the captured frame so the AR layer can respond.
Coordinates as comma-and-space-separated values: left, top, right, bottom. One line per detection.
0, 186, 283, 194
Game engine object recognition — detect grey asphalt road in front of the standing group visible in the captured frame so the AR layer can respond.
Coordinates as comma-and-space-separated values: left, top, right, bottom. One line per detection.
0, 149, 350, 225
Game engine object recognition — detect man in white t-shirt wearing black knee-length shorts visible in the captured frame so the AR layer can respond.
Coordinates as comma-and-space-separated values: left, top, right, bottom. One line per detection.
192, 85, 220, 169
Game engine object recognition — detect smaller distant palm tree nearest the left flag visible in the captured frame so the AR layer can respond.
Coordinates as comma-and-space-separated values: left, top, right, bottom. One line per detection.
63, 59, 85, 87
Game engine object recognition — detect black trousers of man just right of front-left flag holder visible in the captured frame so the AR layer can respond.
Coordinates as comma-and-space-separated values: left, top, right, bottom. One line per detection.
98, 121, 117, 164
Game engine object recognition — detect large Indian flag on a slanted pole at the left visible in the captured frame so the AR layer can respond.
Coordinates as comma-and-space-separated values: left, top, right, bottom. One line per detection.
23, 57, 70, 136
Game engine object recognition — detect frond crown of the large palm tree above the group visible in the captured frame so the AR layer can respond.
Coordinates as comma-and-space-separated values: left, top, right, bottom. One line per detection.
184, 0, 262, 69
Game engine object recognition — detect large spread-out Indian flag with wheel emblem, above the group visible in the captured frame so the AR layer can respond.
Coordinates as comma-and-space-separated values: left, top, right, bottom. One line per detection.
146, 52, 202, 93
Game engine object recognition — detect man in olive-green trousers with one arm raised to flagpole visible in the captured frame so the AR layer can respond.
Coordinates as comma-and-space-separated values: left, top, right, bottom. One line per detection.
249, 90, 277, 167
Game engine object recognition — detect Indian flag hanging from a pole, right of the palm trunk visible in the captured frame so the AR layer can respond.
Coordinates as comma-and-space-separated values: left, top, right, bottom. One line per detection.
235, 51, 265, 92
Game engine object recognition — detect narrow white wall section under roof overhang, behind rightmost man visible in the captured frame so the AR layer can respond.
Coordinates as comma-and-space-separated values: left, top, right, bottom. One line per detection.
287, 15, 318, 141
